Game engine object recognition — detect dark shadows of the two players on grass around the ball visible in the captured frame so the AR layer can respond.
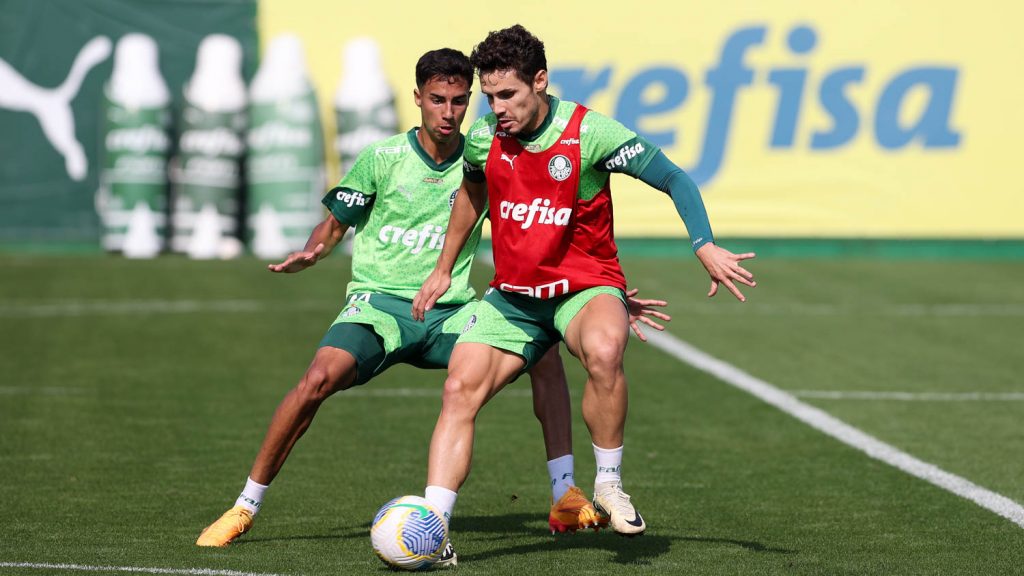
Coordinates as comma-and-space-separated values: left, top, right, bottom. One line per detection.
232, 513, 798, 565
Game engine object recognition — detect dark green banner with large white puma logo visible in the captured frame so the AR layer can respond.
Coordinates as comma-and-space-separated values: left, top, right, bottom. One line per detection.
0, 0, 257, 250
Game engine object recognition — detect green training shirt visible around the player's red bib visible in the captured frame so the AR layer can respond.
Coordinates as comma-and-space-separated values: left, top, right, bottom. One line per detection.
463, 96, 658, 201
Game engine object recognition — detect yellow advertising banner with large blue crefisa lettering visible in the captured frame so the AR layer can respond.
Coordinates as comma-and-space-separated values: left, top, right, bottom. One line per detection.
260, 0, 1024, 239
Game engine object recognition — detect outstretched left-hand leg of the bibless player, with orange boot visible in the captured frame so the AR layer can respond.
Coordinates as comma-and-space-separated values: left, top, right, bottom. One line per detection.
196, 346, 356, 546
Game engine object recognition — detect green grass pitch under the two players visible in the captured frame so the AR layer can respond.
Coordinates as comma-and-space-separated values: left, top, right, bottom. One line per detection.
0, 255, 1024, 575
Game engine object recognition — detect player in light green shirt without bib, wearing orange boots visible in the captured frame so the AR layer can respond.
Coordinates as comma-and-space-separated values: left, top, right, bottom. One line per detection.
197, 48, 668, 553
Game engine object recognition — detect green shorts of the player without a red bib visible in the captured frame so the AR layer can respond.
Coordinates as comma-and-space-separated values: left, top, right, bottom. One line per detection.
319, 293, 477, 385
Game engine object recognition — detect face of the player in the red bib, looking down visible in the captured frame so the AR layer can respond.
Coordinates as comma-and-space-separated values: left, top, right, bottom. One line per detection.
480, 70, 548, 134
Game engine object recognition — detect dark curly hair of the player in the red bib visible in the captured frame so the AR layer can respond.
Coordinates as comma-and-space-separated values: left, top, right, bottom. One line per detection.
469, 24, 548, 84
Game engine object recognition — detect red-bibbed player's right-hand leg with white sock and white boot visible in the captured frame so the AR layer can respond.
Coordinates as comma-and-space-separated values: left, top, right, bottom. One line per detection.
565, 294, 646, 536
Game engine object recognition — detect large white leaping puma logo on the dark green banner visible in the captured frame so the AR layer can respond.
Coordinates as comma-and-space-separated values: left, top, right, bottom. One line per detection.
0, 36, 111, 181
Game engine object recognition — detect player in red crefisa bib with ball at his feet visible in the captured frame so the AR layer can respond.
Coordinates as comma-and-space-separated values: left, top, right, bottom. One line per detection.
413, 26, 755, 536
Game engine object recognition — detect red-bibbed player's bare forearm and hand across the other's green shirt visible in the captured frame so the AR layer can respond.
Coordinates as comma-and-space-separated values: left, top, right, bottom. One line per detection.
413, 177, 487, 321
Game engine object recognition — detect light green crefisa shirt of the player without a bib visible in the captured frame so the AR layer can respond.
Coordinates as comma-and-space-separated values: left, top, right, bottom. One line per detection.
324, 128, 483, 304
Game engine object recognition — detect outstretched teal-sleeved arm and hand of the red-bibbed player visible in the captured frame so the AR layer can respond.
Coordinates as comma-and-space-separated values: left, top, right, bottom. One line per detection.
597, 129, 757, 301
